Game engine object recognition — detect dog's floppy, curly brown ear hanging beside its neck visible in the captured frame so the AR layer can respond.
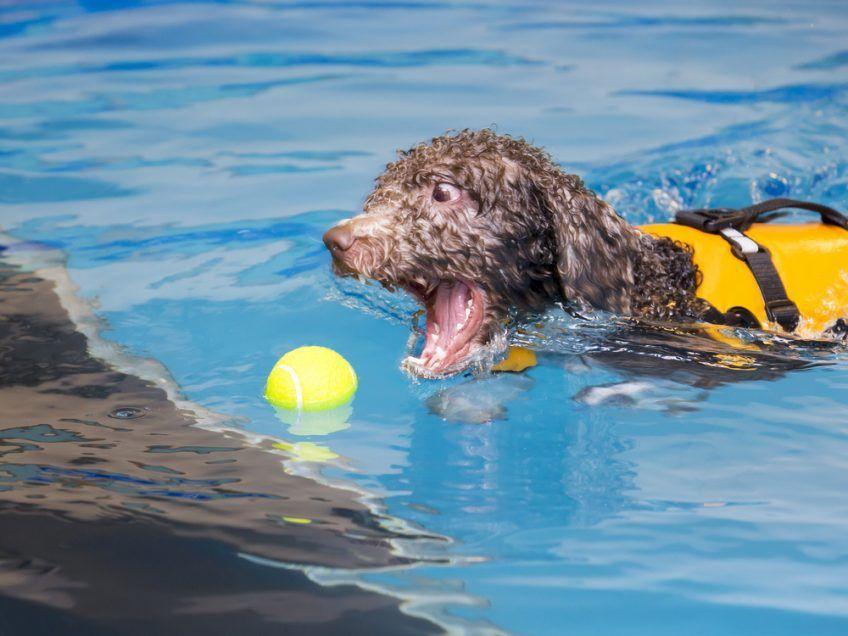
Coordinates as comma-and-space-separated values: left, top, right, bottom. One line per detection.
537, 175, 638, 314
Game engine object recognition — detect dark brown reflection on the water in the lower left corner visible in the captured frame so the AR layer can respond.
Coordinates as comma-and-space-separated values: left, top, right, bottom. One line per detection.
0, 262, 432, 634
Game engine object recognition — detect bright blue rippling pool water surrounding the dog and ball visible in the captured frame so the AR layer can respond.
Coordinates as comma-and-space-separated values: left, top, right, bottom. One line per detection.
0, 0, 848, 635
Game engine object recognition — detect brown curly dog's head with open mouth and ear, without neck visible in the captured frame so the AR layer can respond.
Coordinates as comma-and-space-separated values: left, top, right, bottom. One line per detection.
324, 130, 632, 377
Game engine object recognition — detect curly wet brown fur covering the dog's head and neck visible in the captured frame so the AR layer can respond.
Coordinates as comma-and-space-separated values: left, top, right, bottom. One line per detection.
328, 129, 720, 370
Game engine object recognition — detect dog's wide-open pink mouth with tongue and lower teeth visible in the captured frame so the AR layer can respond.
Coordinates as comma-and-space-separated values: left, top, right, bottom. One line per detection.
405, 281, 486, 377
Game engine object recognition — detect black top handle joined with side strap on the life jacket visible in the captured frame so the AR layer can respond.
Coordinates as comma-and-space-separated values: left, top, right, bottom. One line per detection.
675, 199, 848, 332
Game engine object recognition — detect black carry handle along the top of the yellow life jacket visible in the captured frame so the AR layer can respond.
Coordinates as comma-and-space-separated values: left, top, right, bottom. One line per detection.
674, 198, 848, 234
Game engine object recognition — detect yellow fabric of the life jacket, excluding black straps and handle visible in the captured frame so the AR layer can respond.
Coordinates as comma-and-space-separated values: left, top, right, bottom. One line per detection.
639, 223, 848, 338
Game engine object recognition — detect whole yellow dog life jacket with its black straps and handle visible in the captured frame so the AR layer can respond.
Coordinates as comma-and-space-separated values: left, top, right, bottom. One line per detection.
639, 199, 848, 338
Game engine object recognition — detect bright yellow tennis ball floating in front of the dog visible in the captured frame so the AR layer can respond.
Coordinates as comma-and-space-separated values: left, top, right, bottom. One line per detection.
265, 347, 357, 411
